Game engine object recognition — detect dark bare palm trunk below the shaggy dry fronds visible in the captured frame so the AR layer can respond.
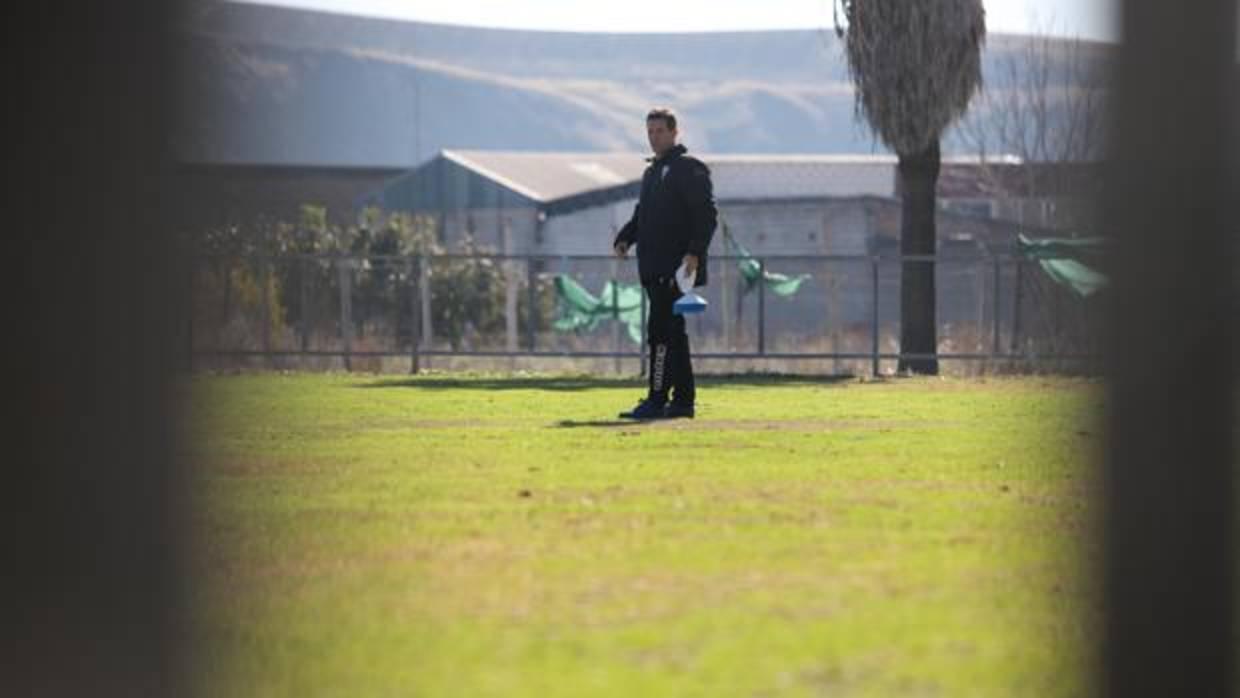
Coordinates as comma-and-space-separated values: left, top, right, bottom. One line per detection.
898, 140, 939, 376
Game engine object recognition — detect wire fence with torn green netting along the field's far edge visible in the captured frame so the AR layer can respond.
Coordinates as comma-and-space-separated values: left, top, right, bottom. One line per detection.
184, 247, 1097, 374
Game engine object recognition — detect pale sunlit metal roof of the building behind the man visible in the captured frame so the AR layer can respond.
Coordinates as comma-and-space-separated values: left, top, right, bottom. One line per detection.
443, 150, 1016, 203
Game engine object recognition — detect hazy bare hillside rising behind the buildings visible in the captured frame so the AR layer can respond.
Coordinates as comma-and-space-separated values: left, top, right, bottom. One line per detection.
174, 2, 1107, 166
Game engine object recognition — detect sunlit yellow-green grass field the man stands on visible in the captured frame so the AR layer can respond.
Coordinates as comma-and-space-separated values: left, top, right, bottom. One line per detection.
191, 374, 1101, 697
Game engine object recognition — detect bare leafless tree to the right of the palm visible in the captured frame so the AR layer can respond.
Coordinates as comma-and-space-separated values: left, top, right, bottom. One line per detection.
954, 24, 1112, 352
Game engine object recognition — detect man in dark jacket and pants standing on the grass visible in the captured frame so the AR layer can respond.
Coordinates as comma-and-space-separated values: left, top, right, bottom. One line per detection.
611, 109, 717, 419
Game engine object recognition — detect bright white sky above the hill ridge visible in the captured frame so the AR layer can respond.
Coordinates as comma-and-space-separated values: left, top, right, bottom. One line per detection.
225, 0, 1118, 41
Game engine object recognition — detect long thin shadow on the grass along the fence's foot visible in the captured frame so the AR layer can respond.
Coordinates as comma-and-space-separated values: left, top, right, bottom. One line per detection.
355, 373, 856, 392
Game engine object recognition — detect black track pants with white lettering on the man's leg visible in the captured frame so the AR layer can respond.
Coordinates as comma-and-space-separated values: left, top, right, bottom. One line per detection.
645, 279, 697, 405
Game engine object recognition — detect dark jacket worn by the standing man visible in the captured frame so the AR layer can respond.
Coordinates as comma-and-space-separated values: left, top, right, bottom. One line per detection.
613, 145, 717, 286
